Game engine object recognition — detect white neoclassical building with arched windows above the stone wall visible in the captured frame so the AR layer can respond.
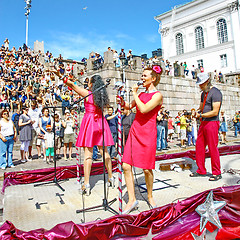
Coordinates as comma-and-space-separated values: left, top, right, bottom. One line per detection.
155, 0, 240, 73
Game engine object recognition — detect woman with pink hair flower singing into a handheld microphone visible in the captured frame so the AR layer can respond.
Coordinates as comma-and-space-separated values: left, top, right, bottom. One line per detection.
121, 66, 162, 214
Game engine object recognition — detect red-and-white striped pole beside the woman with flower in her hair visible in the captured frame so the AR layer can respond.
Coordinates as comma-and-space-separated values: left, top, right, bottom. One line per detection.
117, 89, 122, 215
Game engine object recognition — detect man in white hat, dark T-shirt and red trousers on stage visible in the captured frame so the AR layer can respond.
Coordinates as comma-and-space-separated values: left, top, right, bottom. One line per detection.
190, 73, 222, 181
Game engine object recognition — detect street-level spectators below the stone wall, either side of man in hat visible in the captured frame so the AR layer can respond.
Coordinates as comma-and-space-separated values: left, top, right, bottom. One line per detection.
157, 106, 240, 151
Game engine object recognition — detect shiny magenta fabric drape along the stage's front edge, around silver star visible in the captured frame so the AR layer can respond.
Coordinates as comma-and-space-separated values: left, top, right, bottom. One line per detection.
0, 186, 240, 240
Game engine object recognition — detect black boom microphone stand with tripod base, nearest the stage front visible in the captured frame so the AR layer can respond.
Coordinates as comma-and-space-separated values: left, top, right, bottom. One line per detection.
74, 81, 118, 214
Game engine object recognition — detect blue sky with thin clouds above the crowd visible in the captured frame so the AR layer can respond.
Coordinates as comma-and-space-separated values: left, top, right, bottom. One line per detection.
0, 0, 189, 60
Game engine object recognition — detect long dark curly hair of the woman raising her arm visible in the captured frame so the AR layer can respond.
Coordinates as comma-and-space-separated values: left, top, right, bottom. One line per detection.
90, 75, 109, 108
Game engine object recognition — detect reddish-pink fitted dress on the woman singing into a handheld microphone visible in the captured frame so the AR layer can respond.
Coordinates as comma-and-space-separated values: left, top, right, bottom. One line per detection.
122, 92, 161, 169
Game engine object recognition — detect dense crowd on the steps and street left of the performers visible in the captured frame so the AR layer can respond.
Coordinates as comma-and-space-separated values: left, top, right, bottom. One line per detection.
0, 39, 83, 169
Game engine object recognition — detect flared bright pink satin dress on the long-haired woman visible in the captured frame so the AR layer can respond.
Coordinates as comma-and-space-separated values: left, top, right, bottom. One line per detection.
76, 92, 114, 147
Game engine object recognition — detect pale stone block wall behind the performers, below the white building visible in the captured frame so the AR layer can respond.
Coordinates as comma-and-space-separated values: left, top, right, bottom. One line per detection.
77, 67, 240, 116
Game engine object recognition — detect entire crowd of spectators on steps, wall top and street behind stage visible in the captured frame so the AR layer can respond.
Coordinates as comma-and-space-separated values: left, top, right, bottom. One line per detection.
0, 39, 237, 169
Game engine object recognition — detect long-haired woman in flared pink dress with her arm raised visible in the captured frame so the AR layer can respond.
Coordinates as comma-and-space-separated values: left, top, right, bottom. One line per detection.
56, 73, 114, 195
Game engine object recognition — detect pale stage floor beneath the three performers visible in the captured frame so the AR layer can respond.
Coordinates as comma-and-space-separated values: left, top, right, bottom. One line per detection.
3, 155, 240, 231
